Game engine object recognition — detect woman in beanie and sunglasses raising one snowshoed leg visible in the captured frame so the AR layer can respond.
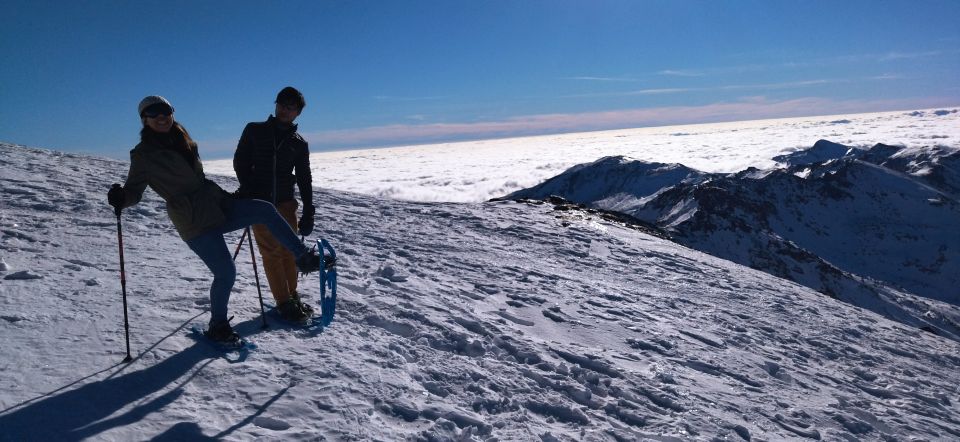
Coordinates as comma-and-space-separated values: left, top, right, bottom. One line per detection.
107, 95, 320, 342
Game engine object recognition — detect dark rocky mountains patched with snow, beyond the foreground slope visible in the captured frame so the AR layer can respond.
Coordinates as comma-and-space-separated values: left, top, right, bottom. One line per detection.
507, 140, 960, 338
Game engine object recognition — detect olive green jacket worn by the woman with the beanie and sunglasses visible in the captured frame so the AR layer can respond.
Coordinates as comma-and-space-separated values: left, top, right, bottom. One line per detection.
123, 141, 230, 241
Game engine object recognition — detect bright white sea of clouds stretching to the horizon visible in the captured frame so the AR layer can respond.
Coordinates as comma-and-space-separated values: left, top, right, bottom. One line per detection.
204, 108, 960, 202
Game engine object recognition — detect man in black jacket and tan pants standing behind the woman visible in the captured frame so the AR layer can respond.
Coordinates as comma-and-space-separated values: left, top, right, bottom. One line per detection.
233, 86, 315, 322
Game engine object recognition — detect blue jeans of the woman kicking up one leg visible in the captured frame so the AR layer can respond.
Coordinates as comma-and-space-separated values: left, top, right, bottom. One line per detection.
187, 200, 309, 321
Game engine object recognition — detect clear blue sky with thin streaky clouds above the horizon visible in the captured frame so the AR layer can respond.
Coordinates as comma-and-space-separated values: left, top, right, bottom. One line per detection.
0, 0, 960, 159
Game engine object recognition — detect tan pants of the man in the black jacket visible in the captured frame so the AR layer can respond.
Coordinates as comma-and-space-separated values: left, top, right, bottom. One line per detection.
253, 201, 299, 305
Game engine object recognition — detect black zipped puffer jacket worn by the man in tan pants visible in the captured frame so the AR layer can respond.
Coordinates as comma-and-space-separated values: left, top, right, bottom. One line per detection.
233, 115, 313, 207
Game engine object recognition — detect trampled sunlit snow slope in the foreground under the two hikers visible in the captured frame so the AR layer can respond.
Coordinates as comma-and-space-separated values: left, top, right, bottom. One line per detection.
0, 145, 960, 441
